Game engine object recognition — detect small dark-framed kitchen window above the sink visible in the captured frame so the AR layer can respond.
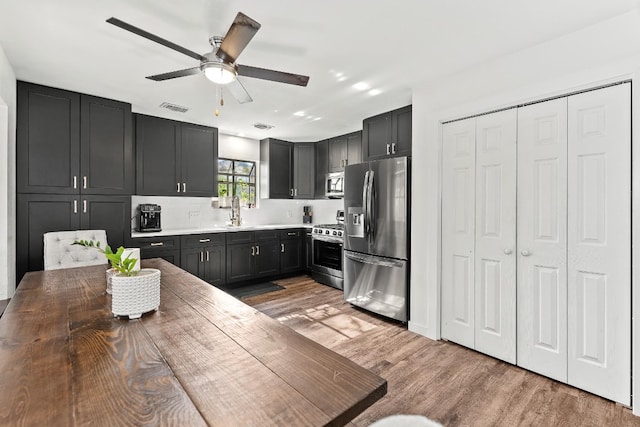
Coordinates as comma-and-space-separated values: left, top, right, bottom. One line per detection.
218, 159, 256, 206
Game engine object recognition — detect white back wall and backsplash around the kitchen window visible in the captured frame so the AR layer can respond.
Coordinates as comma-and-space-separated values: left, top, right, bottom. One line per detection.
131, 134, 343, 230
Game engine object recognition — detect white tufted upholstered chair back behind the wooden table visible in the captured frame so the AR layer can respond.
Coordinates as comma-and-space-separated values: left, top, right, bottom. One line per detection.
44, 230, 107, 270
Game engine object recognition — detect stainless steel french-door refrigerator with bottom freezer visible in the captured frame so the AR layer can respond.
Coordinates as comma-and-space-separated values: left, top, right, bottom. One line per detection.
343, 157, 411, 322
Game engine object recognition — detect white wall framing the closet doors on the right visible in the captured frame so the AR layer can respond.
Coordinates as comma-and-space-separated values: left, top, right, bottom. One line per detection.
409, 11, 640, 415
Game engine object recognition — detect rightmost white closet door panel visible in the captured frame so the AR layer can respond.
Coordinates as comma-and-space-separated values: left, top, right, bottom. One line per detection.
568, 84, 631, 405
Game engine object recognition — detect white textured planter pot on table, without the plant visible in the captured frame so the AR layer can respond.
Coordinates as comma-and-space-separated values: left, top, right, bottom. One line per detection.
111, 268, 160, 319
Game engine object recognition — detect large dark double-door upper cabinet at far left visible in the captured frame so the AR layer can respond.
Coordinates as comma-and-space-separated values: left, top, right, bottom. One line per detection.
16, 82, 134, 195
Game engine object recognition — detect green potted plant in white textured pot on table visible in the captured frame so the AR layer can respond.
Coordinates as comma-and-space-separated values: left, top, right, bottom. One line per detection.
72, 240, 160, 319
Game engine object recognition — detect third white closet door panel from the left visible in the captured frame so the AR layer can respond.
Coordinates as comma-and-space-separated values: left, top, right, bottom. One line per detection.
517, 98, 567, 382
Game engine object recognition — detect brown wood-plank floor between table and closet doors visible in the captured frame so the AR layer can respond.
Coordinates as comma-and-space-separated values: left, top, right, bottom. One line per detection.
243, 276, 640, 426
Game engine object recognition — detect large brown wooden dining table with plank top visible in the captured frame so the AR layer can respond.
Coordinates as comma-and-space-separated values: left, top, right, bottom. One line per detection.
0, 259, 387, 426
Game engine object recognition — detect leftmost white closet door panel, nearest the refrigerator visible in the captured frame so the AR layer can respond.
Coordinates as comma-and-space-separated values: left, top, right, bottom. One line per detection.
441, 119, 476, 348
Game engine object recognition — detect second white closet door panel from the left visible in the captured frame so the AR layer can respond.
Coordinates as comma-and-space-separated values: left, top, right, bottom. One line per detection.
475, 108, 516, 363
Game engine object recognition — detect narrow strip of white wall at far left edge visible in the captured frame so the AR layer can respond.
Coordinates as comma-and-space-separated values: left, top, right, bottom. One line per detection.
0, 41, 16, 300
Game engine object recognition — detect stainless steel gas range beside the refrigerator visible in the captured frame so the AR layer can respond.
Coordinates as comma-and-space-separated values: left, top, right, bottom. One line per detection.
311, 211, 344, 289
